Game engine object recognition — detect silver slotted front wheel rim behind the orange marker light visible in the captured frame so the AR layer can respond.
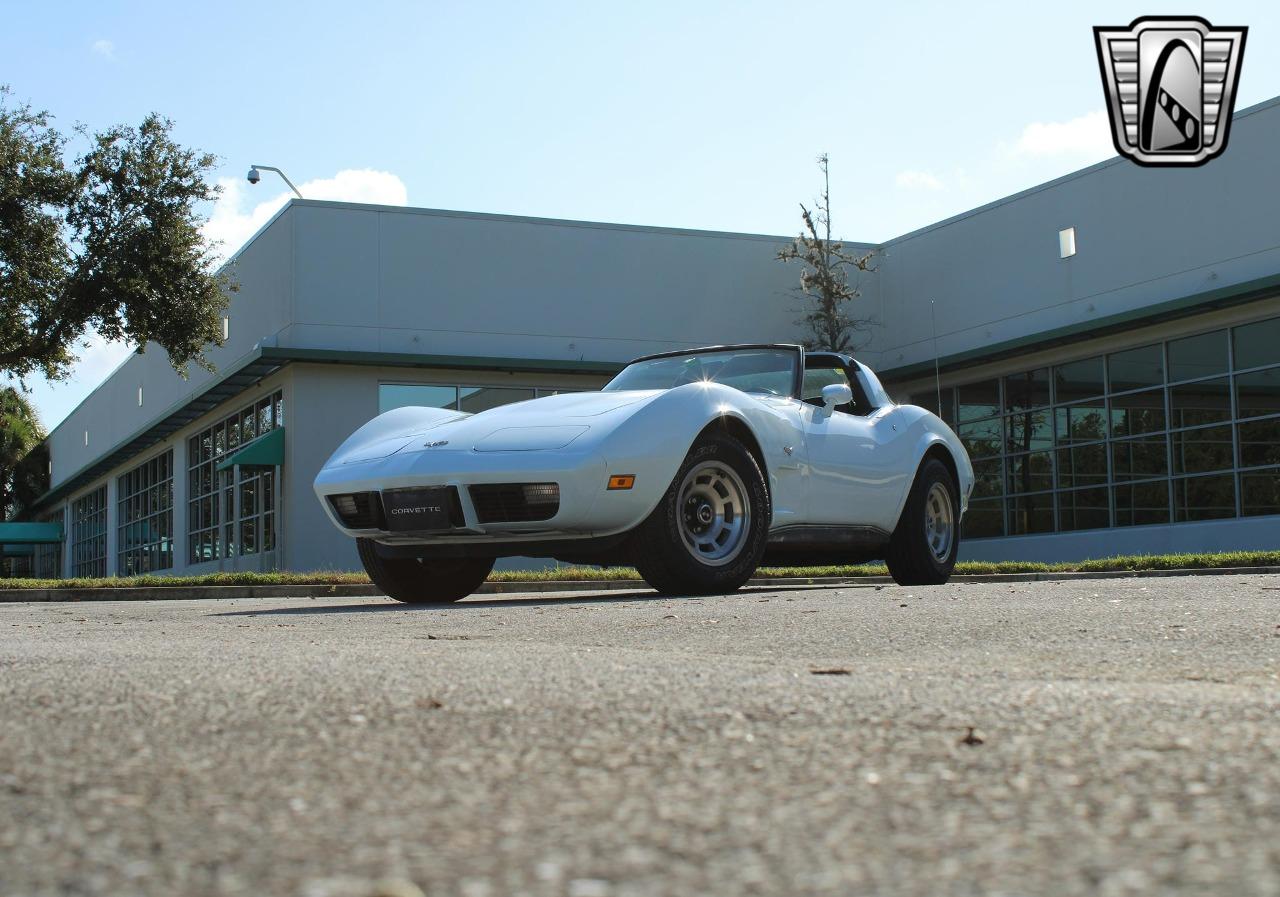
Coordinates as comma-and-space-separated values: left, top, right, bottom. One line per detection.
677, 461, 751, 567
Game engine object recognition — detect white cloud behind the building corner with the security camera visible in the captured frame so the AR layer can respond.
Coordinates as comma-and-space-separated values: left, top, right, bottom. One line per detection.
204, 169, 408, 258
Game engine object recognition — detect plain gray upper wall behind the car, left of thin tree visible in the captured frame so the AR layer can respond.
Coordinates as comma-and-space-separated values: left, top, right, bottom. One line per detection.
276, 201, 824, 361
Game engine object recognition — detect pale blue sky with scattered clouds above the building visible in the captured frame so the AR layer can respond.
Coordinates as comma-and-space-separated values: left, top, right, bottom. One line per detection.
0, 0, 1280, 429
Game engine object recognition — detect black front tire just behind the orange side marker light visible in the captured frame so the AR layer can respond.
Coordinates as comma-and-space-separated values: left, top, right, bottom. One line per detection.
631, 433, 772, 595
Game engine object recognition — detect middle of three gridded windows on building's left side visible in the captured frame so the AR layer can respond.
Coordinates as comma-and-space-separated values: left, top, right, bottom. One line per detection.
115, 449, 173, 576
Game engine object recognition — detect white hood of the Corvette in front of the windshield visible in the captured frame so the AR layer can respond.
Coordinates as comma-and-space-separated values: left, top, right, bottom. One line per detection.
342, 390, 662, 463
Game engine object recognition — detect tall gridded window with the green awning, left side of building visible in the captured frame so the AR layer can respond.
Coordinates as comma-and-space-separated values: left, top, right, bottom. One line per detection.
187, 392, 284, 564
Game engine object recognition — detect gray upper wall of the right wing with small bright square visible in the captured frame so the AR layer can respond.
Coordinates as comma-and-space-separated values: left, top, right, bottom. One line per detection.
868, 99, 1280, 371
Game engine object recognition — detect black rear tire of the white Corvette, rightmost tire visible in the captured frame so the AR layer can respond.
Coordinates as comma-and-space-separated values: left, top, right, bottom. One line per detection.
884, 458, 960, 586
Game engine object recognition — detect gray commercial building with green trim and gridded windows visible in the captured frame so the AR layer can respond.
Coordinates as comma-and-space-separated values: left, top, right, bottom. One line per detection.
17, 99, 1280, 576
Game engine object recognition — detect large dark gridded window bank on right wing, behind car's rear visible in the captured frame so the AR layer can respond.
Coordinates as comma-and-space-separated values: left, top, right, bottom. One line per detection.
910, 317, 1280, 539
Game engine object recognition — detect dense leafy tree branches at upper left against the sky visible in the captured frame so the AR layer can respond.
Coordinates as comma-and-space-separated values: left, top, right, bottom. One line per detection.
0, 87, 234, 379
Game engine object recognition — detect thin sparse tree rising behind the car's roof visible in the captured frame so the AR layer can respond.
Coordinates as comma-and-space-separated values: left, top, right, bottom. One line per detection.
777, 154, 876, 352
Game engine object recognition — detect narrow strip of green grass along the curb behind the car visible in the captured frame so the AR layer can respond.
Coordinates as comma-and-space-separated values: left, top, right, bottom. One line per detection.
0, 552, 1280, 589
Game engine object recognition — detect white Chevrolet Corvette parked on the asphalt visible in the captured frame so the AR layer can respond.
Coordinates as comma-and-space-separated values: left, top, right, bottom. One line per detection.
315, 345, 974, 603
